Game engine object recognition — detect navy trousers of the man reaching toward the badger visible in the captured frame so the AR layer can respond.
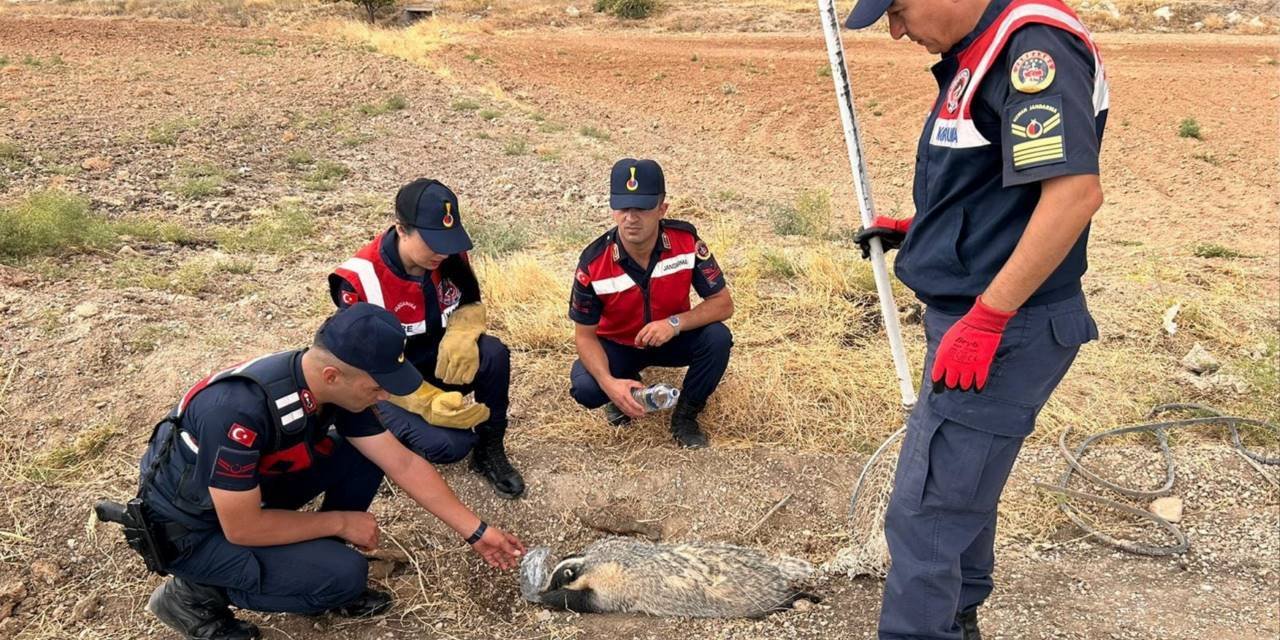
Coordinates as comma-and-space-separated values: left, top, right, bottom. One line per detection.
166, 439, 383, 613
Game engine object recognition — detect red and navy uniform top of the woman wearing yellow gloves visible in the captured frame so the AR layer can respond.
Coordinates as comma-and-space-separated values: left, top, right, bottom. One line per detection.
329, 227, 480, 367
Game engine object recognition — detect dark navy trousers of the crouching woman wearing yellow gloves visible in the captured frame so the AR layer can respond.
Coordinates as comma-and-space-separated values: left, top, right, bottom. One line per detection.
376, 334, 511, 465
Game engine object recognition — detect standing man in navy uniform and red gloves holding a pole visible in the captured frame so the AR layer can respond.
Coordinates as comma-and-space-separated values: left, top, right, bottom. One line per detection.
846, 0, 1107, 640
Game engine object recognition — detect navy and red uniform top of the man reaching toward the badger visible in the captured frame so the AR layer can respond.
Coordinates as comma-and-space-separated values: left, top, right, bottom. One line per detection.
184, 358, 385, 522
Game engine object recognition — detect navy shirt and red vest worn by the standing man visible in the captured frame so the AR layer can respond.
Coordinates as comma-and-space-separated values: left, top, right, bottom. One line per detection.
895, 0, 1110, 314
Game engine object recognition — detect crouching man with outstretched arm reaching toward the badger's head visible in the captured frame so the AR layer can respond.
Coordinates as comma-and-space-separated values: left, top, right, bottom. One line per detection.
131, 303, 524, 639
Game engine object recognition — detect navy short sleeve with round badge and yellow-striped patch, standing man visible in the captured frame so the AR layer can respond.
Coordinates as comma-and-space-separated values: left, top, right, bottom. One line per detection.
988, 24, 1100, 187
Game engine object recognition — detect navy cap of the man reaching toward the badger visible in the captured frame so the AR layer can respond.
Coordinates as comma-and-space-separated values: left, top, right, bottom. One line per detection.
316, 302, 422, 396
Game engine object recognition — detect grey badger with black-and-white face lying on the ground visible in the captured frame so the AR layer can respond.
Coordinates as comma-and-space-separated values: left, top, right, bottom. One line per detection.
536, 538, 820, 618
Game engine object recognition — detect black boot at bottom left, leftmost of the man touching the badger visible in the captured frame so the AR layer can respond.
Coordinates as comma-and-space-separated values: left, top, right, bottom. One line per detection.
147, 576, 259, 640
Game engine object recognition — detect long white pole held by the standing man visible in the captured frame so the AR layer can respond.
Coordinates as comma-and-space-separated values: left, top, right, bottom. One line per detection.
818, 0, 915, 407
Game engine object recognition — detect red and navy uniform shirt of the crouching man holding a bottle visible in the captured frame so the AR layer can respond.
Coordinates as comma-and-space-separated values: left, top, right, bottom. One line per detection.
568, 220, 726, 346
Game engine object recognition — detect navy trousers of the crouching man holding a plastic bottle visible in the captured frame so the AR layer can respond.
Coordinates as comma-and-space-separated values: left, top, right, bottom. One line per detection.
570, 323, 733, 408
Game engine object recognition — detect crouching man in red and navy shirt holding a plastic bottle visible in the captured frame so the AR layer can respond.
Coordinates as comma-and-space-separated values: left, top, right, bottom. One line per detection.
568, 157, 733, 448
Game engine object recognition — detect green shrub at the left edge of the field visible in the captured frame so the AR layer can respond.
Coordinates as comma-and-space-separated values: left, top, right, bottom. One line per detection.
0, 191, 114, 259
